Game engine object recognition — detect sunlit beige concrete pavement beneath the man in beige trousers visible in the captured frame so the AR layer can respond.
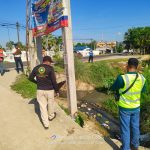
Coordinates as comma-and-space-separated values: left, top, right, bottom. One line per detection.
0, 71, 113, 150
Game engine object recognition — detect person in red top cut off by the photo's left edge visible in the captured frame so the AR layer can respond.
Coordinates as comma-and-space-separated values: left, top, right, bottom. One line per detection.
0, 48, 7, 76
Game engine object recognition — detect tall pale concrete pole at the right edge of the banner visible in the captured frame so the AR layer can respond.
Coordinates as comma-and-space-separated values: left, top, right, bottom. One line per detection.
62, 0, 77, 117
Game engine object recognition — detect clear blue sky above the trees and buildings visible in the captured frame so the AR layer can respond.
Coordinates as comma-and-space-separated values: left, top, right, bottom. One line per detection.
0, 0, 150, 46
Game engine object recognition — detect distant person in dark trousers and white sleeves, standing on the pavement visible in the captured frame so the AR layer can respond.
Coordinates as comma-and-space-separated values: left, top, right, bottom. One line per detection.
12, 44, 24, 73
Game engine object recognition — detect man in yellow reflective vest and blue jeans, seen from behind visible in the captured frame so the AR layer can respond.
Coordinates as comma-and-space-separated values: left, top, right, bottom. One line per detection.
112, 58, 146, 150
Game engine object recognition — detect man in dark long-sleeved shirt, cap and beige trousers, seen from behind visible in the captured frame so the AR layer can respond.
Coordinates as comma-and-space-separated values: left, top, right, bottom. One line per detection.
29, 56, 59, 129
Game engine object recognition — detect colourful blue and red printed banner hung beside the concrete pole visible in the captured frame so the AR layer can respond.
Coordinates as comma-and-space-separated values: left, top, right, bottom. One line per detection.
32, 0, 68, 37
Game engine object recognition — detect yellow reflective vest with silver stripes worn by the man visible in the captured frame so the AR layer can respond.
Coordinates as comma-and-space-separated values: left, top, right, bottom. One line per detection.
118, 74, 146, 109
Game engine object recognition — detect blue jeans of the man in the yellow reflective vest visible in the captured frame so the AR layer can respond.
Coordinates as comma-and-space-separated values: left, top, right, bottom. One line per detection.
119, 108, 140, 150
